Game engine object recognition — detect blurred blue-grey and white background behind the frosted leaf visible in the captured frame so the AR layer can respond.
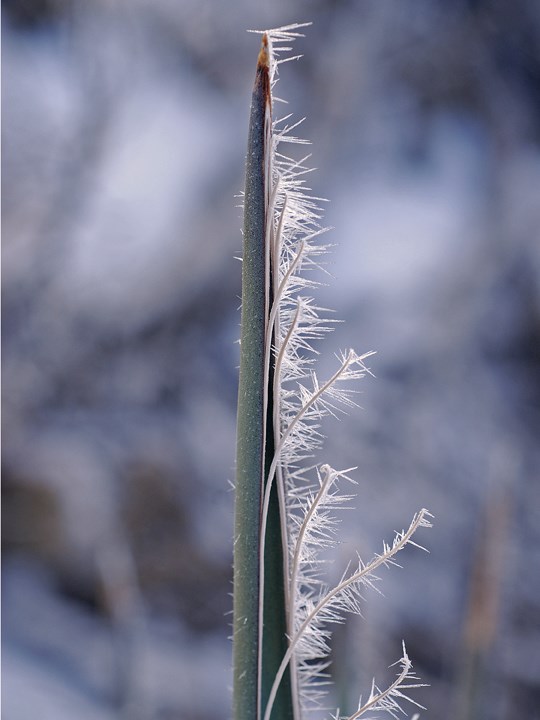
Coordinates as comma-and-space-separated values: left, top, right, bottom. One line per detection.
2, 0, 540, 720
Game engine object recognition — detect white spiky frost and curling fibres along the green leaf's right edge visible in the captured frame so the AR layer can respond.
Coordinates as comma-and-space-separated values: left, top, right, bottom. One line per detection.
248, 23, 430, 720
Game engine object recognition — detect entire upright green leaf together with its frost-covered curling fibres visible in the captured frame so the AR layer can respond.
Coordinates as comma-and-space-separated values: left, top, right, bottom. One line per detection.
233, 23, 431, 720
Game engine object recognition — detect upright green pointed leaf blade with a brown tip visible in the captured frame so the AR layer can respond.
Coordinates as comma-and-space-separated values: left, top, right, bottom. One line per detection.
233, 38, 293, 720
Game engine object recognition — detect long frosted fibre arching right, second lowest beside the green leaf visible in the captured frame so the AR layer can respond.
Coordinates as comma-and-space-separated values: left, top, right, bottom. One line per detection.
264, 510, 430, 720
